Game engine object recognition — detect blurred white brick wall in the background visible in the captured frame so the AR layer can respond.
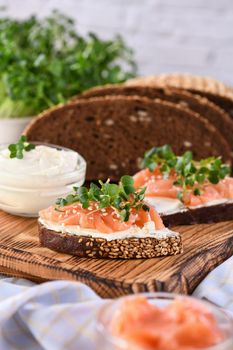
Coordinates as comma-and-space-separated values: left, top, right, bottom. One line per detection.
0, 0, 233, 85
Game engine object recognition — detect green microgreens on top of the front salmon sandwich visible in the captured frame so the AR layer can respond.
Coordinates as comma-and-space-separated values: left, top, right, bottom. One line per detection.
56, 175, 149, 221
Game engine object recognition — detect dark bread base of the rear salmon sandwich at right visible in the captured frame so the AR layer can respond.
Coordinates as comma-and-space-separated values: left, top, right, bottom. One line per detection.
160, 203, 233, 226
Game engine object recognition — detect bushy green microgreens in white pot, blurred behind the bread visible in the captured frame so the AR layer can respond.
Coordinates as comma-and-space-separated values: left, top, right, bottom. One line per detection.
0, 11, 136, 143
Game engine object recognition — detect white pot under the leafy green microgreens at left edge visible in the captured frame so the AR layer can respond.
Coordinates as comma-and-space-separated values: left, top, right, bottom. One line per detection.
0, 117, 32, 143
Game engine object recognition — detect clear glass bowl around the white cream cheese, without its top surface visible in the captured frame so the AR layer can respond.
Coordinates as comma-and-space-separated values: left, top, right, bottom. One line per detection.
0, 142, 86, 217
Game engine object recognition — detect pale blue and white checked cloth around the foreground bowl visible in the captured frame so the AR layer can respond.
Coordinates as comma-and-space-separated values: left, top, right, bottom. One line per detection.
0, 257, 233, 350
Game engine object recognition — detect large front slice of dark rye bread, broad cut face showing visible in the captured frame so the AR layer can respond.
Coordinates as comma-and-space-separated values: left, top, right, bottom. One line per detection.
25, 96, 230, 181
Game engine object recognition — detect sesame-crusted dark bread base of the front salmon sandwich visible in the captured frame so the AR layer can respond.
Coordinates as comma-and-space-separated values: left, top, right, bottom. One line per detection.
38, 223, 182, 259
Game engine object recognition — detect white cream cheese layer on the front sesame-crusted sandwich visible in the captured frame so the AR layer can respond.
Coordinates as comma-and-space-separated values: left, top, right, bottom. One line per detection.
39, 218, 177, 241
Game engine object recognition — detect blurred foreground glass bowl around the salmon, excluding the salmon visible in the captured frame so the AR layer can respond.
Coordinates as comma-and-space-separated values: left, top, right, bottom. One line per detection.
96, 293, 233, 350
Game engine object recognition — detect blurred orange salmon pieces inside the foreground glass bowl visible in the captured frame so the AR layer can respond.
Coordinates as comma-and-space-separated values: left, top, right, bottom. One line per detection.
110, 296, 224, 350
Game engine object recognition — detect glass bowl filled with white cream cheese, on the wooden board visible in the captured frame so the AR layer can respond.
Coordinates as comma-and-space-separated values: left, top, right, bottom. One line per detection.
0, 144, 86, 217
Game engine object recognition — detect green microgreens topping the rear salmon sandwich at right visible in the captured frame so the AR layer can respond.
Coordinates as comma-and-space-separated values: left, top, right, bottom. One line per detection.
141, 145, 231, 200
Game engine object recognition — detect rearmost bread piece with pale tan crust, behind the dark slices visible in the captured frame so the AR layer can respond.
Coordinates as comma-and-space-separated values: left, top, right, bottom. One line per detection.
126, 73, 233, 119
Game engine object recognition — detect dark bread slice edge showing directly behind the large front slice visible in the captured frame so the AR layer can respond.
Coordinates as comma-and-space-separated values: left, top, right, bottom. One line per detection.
72, 84, 233, 150
